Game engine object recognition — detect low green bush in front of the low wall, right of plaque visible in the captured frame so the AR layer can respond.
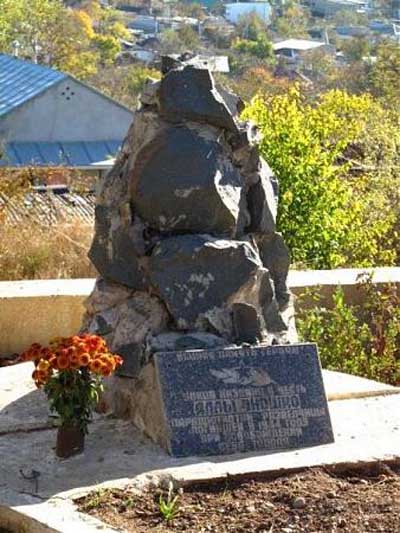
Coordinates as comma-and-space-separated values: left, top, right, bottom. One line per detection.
297, 281, 400, 385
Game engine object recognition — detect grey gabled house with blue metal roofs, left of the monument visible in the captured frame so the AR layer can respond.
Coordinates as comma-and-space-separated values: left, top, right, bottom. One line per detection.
0, 54, 133, 171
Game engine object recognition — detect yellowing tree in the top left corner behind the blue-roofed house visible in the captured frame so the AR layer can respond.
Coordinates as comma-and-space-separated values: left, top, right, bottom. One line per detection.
0, 0, 129, 78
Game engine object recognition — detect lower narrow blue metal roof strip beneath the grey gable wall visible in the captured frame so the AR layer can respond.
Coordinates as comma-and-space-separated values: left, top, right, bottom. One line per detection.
0, 140, 122, 168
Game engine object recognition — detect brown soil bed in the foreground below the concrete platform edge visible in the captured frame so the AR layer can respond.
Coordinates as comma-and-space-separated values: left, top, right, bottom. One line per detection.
77, 464, 400, 533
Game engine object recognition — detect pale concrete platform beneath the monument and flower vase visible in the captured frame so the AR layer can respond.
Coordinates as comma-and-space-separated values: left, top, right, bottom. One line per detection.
0, 363, 400, 533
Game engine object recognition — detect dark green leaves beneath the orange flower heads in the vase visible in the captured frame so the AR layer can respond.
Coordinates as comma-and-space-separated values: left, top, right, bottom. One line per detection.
44, 368, 103, 433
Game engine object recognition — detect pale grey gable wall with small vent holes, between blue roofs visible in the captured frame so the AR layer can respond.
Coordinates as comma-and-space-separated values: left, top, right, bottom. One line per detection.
0, 78, 133, 142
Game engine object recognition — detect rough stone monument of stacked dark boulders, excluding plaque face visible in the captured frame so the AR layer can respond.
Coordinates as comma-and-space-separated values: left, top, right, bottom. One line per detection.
84, 57, 332, 454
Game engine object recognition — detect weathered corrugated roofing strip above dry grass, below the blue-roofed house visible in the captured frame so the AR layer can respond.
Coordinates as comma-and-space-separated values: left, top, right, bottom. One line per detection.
0, 189, 96, 225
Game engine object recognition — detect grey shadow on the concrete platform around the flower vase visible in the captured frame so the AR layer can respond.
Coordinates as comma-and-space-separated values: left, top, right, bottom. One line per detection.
0, 384, 282, 505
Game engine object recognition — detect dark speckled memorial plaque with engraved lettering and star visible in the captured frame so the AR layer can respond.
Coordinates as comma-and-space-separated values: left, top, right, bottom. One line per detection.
155, 344, 334, 457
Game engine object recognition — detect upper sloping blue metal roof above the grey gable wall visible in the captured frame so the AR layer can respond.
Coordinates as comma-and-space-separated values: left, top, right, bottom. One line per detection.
0, 54, 68, 116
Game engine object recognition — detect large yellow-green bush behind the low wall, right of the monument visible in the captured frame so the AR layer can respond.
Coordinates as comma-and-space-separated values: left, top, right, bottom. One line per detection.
244, 88, 400, 268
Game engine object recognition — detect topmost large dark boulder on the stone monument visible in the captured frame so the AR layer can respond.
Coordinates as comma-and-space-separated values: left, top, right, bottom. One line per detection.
158, 65, 237, 132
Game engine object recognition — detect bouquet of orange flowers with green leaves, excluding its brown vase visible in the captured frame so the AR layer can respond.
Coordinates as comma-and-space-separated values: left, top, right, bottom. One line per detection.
21, 335, 122, 442
